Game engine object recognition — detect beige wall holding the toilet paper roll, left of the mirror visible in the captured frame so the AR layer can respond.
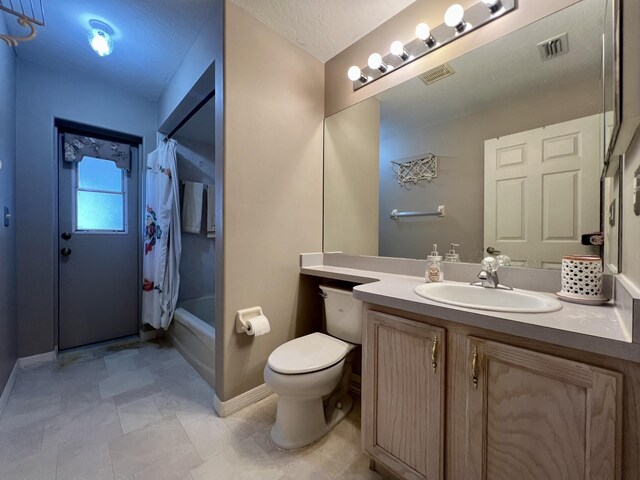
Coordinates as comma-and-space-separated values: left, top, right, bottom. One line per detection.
221, 1, 324, 401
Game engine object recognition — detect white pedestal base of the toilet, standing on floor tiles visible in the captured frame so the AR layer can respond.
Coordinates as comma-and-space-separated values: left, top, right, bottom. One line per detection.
270, 393, 353, 450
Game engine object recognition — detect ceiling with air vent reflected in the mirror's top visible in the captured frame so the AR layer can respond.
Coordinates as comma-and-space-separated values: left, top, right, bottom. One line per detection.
377, 0, 604, 138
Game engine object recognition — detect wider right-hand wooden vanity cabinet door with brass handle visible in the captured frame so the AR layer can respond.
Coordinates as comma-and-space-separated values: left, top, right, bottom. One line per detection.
467, 337, 622, 480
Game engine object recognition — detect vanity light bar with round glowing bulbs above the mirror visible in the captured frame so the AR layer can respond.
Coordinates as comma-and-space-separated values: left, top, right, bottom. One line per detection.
348, 0, 517, 91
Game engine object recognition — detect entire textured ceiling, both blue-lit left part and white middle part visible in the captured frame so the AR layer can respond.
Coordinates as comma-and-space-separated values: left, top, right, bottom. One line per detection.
7, 0, 415, 101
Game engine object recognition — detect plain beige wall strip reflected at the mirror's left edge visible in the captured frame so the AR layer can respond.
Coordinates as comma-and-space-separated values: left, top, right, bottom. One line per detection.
324, 97, 380, 255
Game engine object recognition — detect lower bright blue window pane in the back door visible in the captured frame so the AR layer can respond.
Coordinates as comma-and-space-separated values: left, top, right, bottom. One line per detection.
76, 190, 125, 231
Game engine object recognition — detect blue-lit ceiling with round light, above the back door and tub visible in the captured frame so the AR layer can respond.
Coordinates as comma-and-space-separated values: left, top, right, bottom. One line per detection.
5, 0, 213, 100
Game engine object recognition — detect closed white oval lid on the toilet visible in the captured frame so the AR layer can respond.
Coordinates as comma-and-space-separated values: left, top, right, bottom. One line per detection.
267, 333, 349, 374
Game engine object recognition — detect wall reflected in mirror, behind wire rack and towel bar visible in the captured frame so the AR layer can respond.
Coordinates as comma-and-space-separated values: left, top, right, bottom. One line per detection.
378, 78, 602, 262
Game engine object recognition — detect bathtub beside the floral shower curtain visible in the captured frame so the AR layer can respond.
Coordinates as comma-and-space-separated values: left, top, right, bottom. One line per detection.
169, 296, 216, 388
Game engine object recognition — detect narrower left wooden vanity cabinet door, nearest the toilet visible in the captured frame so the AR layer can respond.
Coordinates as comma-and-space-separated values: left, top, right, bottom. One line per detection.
362, 311, 446, 480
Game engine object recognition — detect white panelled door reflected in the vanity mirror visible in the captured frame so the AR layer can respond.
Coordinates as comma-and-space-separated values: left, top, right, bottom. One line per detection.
484, 115, 602, 268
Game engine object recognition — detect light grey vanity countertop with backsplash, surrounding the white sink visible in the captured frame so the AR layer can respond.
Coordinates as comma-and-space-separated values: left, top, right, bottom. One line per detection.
301, 254, 640, 362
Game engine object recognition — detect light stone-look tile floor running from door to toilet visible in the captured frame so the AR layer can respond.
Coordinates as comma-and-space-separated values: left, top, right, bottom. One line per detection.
0, 342, 380, 480
